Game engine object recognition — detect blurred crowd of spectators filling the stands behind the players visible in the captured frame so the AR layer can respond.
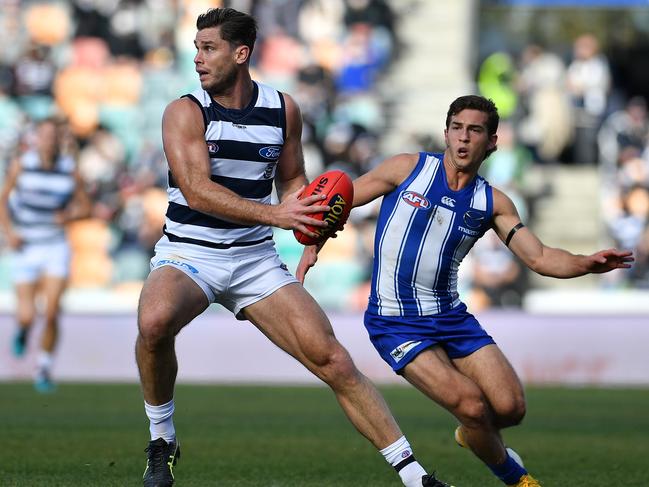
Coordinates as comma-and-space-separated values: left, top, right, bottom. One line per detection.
0, 0, 649, 308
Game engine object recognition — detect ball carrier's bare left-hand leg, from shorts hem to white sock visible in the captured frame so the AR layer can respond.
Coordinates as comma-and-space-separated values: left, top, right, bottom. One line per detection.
135, 266, 209, 405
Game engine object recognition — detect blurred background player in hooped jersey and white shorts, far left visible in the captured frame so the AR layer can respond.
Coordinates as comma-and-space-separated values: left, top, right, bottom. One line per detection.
0, 119, 90, 392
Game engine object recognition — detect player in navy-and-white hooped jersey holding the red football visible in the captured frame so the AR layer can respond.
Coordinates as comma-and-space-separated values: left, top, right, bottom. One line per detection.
136, 8, 447, 487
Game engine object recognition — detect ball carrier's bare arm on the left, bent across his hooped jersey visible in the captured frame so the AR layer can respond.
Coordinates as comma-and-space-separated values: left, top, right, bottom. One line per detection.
162, 98, 321, 232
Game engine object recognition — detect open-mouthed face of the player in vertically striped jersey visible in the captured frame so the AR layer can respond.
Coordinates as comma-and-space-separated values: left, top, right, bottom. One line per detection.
444, 109, 497, 170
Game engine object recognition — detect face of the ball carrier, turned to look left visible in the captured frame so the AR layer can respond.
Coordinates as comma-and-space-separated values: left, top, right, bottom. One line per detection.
194, 27, 248, 95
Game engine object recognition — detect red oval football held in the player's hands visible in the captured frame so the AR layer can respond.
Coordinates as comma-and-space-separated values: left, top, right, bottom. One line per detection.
293, 171, 354, 245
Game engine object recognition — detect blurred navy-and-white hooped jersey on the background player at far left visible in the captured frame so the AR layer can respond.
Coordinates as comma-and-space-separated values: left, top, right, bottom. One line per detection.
8, 150, 75, 243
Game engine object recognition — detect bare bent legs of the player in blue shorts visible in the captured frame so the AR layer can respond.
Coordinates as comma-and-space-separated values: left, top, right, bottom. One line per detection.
404, 345, 524, 465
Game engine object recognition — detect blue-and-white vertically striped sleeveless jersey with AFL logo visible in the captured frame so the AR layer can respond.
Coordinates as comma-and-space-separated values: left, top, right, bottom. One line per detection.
368, 152, 493, 316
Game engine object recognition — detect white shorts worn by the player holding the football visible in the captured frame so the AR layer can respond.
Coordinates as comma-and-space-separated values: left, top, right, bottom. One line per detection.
151, 237, 298, 320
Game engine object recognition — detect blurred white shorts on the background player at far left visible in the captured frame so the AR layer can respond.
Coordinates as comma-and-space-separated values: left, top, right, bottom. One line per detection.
11, 240, 71, 284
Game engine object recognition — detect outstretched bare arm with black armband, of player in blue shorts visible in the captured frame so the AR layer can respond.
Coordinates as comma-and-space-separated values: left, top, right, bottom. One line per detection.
493, 188, 633, 279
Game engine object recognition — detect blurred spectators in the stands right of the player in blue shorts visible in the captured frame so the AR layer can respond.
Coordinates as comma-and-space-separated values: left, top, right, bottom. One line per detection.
475, 33, 649, 304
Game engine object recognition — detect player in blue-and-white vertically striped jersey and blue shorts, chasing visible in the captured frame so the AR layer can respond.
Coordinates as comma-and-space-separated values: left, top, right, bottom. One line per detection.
297, 95, 633, 487
